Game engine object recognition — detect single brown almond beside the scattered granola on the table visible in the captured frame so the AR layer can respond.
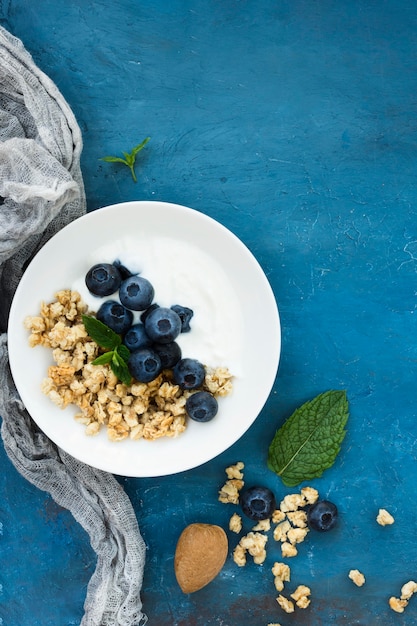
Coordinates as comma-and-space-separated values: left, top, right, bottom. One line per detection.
174, 524, 228, 593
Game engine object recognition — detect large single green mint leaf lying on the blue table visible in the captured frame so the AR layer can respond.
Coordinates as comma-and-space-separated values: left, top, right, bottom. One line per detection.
268, 391, 349, 487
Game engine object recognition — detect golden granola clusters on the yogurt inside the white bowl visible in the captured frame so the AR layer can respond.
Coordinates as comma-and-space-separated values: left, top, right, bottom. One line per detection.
25, 289, 232, 441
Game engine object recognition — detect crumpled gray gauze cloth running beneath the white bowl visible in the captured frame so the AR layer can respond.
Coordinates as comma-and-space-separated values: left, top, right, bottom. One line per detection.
0, 27, 147, 626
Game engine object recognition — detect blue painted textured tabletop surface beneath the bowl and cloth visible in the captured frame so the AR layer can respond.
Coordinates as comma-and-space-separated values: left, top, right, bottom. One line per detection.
0, 0, 417, 626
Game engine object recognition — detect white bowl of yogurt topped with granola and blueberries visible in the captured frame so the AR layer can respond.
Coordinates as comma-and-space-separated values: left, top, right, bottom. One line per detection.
8, 201, 281, 477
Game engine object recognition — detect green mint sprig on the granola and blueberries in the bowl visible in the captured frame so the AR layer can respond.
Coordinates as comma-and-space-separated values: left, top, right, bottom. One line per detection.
82, 315, 132, 386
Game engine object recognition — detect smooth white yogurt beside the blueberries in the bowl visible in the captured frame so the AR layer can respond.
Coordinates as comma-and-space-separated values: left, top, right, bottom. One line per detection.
72, 236, 244, 376
